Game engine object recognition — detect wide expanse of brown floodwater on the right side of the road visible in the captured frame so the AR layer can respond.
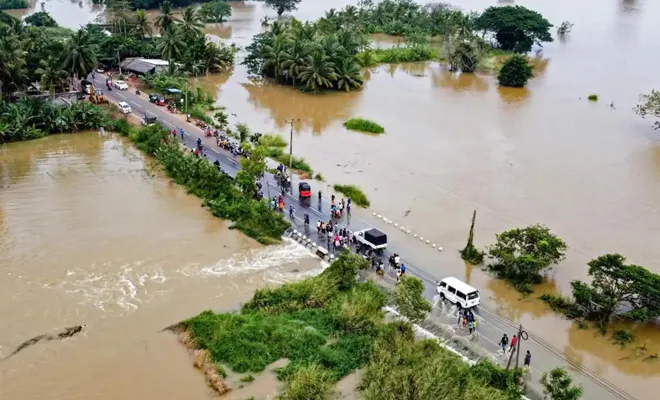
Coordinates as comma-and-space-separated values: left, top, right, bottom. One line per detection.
7, 0, 660, 399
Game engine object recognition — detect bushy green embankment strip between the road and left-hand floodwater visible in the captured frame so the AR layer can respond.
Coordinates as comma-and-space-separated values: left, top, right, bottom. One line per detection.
114, 120, 289, 244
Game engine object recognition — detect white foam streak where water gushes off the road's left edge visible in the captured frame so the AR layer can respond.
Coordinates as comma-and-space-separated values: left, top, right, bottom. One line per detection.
177, 238, 315, 277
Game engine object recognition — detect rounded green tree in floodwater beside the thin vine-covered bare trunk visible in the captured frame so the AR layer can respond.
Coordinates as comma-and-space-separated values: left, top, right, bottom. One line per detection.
488, 225, 568, 291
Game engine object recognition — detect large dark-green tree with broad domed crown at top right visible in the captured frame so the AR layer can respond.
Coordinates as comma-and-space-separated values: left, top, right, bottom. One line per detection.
475, 6, 553, 53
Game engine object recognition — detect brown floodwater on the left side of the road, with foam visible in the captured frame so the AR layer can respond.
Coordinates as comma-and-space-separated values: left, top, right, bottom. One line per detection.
0, 133, 320, 400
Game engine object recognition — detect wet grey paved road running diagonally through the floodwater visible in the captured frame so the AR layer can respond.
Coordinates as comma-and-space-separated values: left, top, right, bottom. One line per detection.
90, 74, 634, 400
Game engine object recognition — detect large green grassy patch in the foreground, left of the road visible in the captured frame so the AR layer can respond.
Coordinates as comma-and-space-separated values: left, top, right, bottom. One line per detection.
178, 252, 518, 400
